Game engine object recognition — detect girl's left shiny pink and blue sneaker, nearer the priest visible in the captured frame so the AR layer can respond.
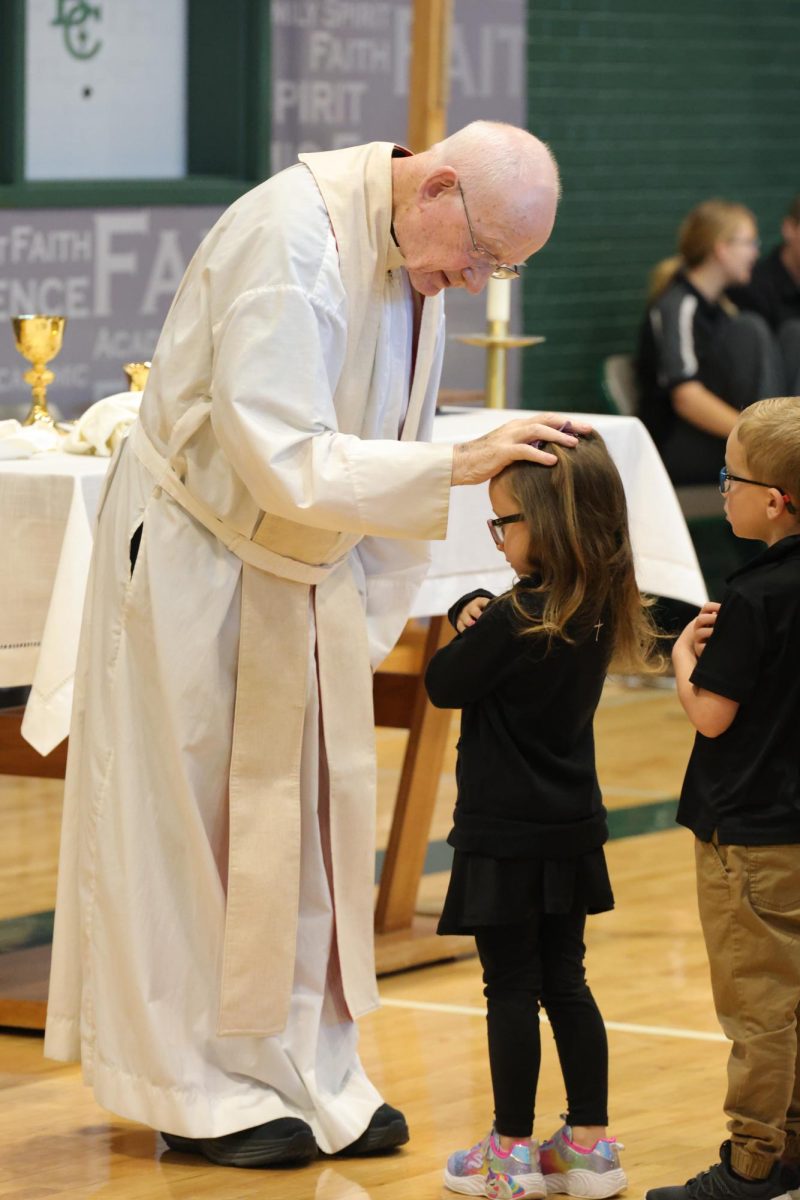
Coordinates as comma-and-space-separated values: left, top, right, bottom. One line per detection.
445, 1129, 547, 1200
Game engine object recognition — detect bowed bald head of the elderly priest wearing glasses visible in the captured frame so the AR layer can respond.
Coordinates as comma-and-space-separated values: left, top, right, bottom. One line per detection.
392, 121, 560, 296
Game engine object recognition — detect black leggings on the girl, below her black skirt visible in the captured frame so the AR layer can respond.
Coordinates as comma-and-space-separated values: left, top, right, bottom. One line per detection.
475, 910, 608, 1138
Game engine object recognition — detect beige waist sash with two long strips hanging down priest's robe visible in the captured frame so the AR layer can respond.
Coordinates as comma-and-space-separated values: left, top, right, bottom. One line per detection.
128, 422, 374, 1037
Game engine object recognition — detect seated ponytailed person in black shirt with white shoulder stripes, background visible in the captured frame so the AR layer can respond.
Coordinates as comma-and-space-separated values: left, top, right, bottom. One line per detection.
637, 199, 782, 485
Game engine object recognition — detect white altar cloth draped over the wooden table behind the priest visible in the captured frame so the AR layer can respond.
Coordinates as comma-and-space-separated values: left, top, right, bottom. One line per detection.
0, 409, 706, 755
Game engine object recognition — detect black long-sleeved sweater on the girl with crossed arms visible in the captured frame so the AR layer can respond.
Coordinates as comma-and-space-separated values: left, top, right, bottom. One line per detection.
425, 578, 610, 858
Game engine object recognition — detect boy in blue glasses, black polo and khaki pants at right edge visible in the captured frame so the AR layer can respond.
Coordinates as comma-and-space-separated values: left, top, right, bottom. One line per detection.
646, 397, 800, 1200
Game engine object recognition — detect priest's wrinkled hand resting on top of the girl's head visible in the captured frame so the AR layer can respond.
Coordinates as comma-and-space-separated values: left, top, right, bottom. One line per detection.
452, 413, 591, 487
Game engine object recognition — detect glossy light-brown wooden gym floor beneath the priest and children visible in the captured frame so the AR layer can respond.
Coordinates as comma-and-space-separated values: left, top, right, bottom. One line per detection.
0, 683, 727, 1200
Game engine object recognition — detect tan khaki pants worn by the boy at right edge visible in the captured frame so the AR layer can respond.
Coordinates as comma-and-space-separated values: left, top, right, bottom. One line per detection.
696, 834, 800, 1178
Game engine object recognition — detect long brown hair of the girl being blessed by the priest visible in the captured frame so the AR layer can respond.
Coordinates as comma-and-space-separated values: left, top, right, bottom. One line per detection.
498, 433, 663, 673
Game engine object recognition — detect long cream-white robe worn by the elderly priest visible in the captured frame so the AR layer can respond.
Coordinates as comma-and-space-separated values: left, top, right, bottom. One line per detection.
46, 143, 452, 1152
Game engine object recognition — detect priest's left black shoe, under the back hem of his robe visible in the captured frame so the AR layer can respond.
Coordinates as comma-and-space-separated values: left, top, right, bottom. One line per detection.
161, 1110, 316, 1166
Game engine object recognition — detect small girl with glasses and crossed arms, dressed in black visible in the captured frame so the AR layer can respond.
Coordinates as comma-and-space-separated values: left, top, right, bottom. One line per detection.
426, 433, 655, 1200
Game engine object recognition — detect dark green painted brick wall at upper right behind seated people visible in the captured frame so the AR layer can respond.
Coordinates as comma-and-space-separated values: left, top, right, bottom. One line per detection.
522, 0, 800, 410
